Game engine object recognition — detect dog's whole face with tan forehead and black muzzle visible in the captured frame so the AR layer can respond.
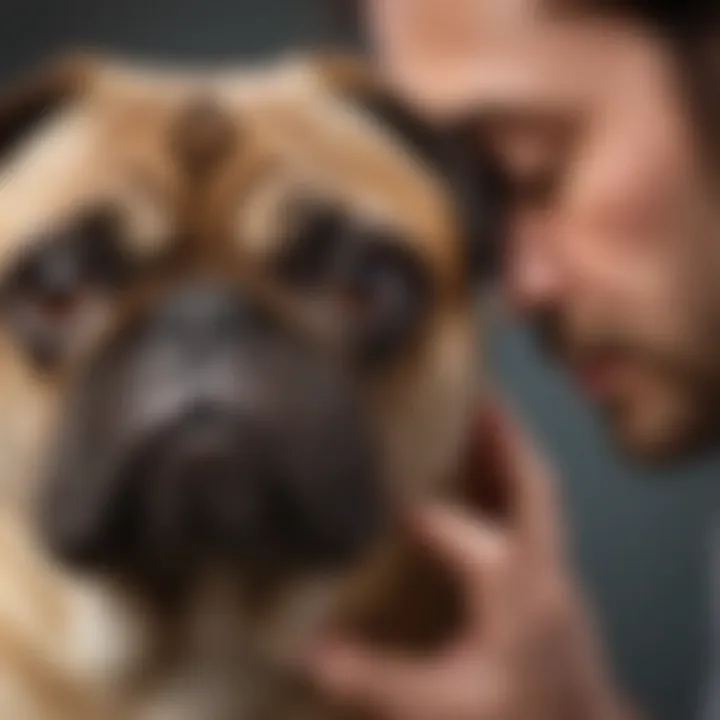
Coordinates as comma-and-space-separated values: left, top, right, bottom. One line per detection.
0, 56, 500, 604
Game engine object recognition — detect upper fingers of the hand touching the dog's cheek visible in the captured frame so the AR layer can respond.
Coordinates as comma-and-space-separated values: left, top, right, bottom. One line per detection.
411, 400, 564, 620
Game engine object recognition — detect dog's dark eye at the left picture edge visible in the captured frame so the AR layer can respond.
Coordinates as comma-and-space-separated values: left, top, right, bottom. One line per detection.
2, 207, 129, 367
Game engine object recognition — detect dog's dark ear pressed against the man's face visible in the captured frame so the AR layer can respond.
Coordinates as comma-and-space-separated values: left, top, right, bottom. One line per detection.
322, 56, 509, 282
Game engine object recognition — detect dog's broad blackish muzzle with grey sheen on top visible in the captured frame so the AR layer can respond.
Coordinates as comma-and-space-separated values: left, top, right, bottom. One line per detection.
42, 282, 385, 579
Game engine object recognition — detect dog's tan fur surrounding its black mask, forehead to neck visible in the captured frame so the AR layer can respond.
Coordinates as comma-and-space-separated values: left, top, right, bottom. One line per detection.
0, 52, 486, 720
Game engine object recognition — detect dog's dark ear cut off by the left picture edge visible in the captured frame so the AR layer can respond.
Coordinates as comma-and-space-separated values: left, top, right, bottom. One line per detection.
0, 54, 94, 162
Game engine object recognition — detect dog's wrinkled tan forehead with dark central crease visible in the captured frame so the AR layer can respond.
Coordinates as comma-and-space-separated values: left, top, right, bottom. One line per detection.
0, 54, 461, 283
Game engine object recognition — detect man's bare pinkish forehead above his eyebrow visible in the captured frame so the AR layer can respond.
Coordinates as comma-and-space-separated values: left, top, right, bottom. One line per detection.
368, 0, 676, 124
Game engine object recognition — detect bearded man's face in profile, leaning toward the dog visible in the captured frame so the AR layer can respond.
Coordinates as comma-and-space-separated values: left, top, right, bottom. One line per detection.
369, 0, 720, 457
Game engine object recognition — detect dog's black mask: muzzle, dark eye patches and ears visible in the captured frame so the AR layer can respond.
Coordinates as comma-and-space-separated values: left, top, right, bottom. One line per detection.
8, 54, 504, 596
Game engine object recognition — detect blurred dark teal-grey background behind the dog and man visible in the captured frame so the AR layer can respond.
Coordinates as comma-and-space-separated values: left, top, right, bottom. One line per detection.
0, 0, 720, 720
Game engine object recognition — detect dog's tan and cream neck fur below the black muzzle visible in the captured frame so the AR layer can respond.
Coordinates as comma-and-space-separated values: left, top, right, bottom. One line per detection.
0, 462, 478, 720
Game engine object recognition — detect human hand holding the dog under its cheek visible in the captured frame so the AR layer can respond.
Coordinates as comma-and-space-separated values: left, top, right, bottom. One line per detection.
312, 408, 629, 720
